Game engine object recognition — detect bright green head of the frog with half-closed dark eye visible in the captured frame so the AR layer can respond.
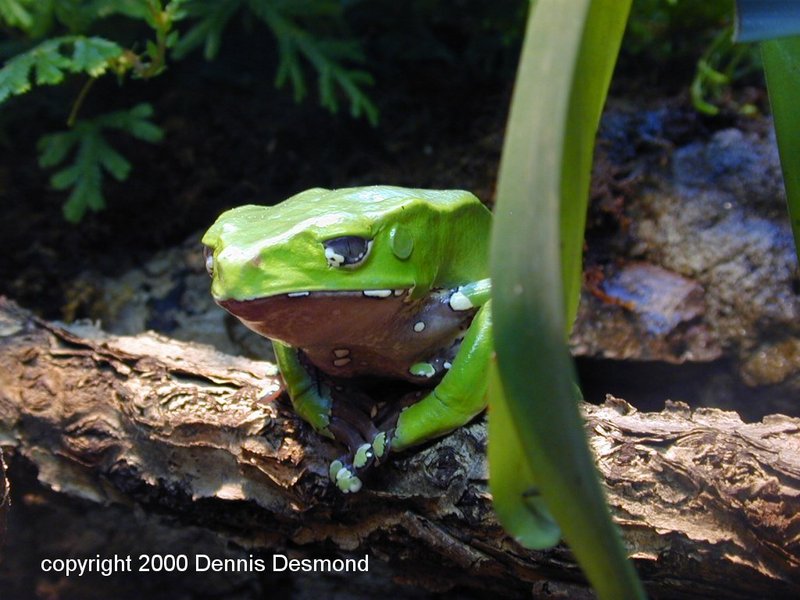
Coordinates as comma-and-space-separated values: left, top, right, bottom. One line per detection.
202, 186, 490, 339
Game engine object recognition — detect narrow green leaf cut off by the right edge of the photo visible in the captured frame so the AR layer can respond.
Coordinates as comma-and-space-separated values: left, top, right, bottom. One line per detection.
761, 37, 800, 256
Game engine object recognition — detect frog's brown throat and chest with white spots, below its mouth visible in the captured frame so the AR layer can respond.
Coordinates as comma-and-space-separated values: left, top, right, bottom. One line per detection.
220, 290, 475, 383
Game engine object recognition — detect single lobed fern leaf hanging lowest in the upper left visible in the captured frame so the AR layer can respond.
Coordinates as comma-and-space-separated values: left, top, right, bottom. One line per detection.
39, 104, 163, 223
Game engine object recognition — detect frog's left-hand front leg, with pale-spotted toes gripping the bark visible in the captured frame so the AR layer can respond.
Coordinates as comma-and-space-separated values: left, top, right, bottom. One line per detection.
273, 341, 385, 493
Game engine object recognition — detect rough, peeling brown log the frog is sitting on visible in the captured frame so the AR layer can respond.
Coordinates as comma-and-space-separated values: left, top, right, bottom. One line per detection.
0, 299, 800, 598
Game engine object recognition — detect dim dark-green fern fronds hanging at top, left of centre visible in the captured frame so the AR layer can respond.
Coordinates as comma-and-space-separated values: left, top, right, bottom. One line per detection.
176, 0, 378, 125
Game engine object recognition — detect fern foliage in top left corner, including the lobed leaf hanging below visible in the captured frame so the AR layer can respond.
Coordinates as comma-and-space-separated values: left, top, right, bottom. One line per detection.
0, 0, 184, 222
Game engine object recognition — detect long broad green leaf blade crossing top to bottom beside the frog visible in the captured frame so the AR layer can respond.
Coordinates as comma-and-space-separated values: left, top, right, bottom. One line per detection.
490, 0, 644, 600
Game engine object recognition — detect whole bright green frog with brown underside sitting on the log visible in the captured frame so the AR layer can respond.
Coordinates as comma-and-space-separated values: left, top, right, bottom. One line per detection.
203, 186, 492, 493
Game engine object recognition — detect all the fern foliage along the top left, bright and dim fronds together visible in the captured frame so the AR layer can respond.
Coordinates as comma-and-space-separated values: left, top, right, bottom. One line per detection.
0, 0, 378, 220
